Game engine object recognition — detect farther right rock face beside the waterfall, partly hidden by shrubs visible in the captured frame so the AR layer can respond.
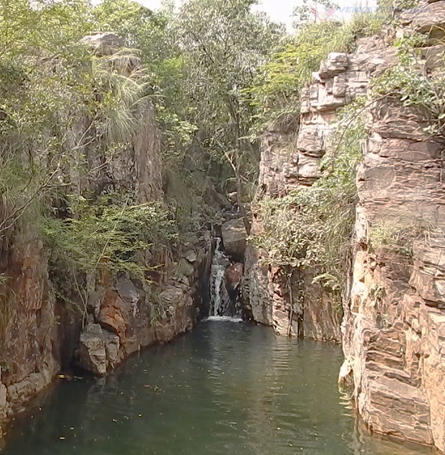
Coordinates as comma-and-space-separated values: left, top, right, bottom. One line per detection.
245, 37, 395, 341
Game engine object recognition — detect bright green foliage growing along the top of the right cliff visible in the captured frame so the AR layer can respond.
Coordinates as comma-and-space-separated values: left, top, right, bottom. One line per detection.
244, 13, 382, 133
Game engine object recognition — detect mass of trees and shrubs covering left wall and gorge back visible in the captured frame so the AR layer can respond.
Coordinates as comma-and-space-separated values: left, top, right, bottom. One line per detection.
0, 0, 292, 318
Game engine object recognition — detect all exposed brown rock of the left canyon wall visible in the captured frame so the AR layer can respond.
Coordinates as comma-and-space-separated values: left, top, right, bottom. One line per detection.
0, 34, 206, 434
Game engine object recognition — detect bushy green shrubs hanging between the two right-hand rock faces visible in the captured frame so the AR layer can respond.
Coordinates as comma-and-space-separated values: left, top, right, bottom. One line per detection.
253, 104, 366, 290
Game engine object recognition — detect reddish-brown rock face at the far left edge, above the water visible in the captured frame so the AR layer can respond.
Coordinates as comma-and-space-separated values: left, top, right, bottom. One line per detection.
0, 240, 61, 430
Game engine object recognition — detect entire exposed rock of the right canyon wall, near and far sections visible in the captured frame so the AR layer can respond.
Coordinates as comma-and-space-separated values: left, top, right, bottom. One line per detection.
245, 1, 445, 451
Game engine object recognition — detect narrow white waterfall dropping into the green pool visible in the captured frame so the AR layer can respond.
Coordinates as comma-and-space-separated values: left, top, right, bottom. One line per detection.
209, 237, 241, 320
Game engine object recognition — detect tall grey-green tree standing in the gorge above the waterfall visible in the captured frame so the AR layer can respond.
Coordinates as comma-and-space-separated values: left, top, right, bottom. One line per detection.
173, 0, 284, 233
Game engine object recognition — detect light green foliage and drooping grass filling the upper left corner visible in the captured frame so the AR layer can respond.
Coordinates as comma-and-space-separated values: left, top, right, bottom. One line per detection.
0, 0, 153, 246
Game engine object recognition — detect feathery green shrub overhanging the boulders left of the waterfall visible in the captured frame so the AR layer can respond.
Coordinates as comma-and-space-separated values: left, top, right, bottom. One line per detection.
42, 194, 178, 280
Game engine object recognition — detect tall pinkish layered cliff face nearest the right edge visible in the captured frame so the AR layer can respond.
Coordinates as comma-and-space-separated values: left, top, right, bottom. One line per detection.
342, 1, 445, 451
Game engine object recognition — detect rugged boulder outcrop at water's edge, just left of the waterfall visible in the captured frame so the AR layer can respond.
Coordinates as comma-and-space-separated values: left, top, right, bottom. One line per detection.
77, 268, 199, 376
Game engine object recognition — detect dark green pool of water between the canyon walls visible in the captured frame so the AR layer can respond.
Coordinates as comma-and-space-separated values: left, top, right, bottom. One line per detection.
1, 321, 431, 455
